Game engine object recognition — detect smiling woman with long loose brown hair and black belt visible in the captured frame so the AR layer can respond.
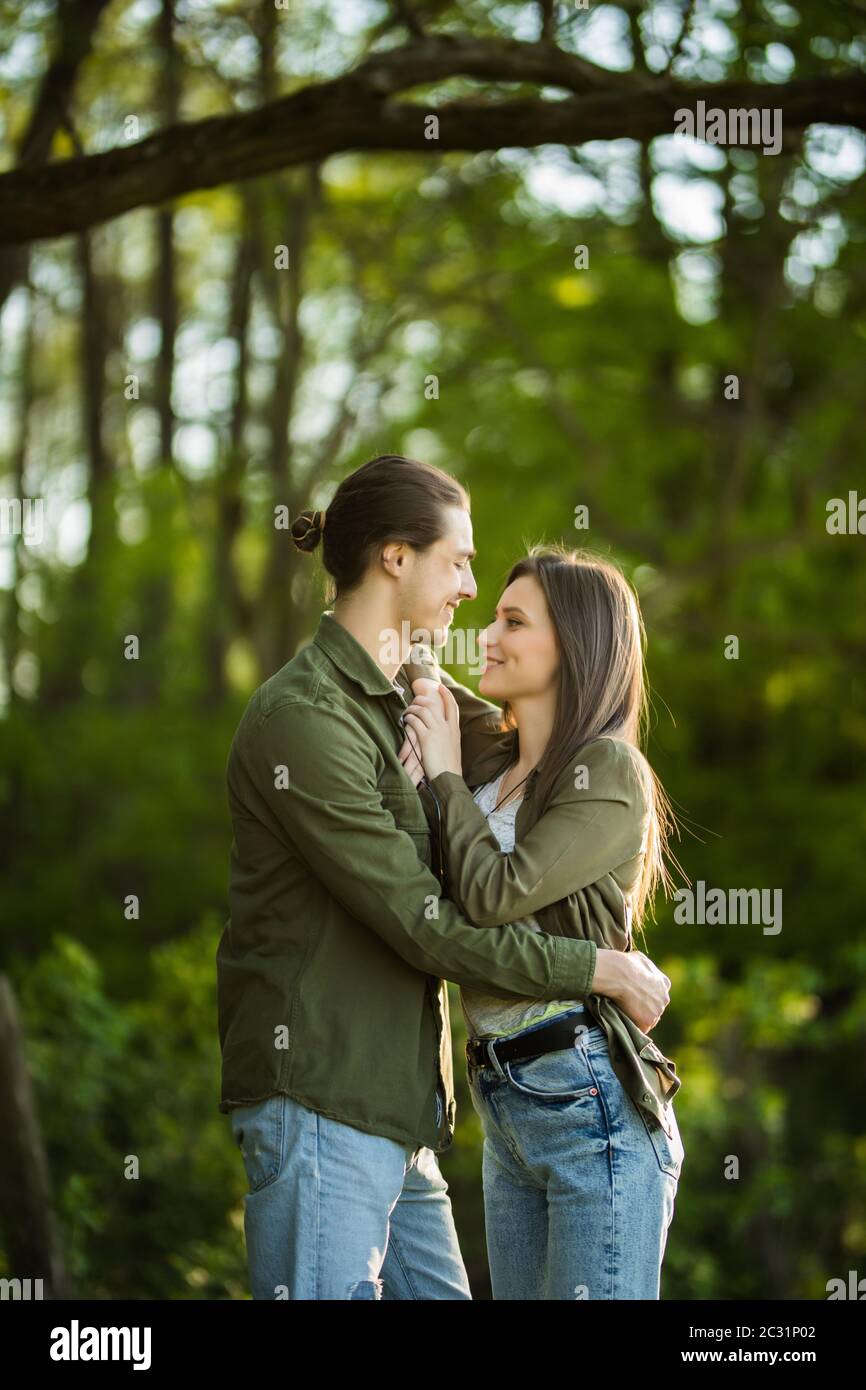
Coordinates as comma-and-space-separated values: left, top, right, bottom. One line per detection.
402, 548, 684, 1300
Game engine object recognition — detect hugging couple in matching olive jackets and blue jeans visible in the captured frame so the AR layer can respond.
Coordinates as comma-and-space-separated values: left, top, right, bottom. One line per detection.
217, 455, 684, 1300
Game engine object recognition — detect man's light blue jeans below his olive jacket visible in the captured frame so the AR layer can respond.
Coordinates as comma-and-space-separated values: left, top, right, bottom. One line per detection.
229, 1095, 471, 1300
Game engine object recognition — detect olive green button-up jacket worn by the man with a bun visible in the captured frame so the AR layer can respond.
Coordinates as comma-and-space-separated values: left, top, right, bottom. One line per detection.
217, 613, 598, 1151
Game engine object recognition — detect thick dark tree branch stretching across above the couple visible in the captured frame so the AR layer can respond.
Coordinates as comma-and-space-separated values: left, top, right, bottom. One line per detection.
0, 38, 866, 243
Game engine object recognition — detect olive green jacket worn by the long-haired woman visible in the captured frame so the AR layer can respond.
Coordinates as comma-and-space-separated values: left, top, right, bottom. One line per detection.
410, 667, 683, 1136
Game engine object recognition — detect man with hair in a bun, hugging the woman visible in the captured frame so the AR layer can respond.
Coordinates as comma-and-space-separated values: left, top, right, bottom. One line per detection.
217, 456, 670, 1300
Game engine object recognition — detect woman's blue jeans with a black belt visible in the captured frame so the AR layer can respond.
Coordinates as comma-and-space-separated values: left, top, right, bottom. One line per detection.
468, 1013, 684, 1300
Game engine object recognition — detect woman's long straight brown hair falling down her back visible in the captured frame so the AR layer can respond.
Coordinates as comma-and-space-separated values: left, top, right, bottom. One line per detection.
503, 545, 680, 929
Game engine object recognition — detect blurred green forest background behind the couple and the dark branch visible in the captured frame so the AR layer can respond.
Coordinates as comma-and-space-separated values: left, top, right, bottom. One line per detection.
0, 0, 866, 1300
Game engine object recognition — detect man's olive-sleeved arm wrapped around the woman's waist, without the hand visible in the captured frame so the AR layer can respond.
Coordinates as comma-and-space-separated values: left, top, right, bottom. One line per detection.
242, 702, 599, 999
